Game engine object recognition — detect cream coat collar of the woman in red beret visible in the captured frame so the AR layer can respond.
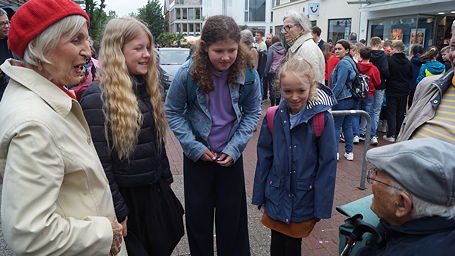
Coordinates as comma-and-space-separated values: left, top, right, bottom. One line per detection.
0, 59, 76, 116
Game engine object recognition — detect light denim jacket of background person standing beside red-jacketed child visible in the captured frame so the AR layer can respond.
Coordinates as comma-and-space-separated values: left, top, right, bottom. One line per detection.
330, 56, 357, 100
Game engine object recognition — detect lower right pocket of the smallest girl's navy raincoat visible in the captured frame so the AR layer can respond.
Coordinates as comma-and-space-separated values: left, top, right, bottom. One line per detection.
294, 180, 314, 216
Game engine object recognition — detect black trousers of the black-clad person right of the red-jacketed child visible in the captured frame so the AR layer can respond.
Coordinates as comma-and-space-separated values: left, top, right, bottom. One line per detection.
387, 95, 408, 137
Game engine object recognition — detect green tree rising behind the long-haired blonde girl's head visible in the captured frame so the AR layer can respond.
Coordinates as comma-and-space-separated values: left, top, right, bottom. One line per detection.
137, 0, 164, 38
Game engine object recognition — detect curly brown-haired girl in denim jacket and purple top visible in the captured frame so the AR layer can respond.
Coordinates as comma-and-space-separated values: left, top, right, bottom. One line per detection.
165, 15, 261, 256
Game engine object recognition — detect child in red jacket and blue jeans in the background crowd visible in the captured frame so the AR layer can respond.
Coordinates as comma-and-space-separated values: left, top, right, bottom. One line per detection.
352, 47, 381, 145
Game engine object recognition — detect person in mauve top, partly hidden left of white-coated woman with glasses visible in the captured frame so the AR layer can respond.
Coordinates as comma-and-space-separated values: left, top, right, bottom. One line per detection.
265, 36, 286, 106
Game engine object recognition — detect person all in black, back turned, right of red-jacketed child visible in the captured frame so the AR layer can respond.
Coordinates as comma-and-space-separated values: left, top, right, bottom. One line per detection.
383, 41, 412, 142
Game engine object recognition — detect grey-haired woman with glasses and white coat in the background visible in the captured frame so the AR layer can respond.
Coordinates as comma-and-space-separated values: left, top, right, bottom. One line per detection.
281, 11, 325, 84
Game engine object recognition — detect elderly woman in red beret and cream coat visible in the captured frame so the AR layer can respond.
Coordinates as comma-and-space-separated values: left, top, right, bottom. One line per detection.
0, 0, 126, 255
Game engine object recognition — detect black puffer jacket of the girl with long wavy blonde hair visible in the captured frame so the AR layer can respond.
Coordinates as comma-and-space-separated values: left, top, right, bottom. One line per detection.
80, 79, 172, 222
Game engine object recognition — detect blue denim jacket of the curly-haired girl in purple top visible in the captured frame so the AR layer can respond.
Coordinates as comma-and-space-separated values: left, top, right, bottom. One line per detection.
165, 61, 261, 161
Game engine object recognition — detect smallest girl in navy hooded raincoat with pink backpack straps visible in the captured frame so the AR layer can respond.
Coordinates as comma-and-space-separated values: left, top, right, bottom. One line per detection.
252, 57, 338, 256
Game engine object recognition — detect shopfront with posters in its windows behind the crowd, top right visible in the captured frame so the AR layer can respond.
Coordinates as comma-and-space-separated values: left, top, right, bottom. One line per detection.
360, 0, 455, 52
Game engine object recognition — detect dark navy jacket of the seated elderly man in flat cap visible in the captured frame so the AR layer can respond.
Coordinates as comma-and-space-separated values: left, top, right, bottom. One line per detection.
357, 217, 455, 256
